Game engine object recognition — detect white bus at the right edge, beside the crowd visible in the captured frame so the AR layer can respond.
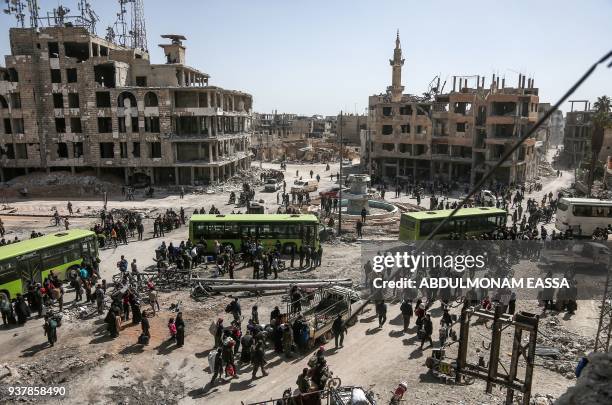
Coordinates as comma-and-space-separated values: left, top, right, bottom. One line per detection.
555, 197, 612, 236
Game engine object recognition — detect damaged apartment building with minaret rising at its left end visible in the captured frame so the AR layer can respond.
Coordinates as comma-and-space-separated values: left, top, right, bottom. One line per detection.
361, 33, 539, 184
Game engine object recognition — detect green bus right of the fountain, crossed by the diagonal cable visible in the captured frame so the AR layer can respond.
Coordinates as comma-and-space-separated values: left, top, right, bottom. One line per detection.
399, 207, 507, 240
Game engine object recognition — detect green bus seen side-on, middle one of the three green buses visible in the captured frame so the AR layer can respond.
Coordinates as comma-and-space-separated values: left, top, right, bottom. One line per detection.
189, 214, 321, 253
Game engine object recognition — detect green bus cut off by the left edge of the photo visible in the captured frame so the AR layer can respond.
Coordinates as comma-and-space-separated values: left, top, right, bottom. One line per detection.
0, 229, 98, 298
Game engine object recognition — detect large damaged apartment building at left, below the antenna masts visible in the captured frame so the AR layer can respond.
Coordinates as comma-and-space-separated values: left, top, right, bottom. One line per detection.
0, 24, 253, 185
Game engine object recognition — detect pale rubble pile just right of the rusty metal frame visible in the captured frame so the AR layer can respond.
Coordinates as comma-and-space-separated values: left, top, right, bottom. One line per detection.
536, 316, 594, 379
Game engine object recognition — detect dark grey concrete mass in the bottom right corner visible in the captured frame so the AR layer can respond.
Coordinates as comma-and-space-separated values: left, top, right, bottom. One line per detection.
555, 353, 612, 405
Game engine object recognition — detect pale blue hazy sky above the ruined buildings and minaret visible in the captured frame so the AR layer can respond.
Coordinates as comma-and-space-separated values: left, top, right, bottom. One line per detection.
0, 0, 612, 115
